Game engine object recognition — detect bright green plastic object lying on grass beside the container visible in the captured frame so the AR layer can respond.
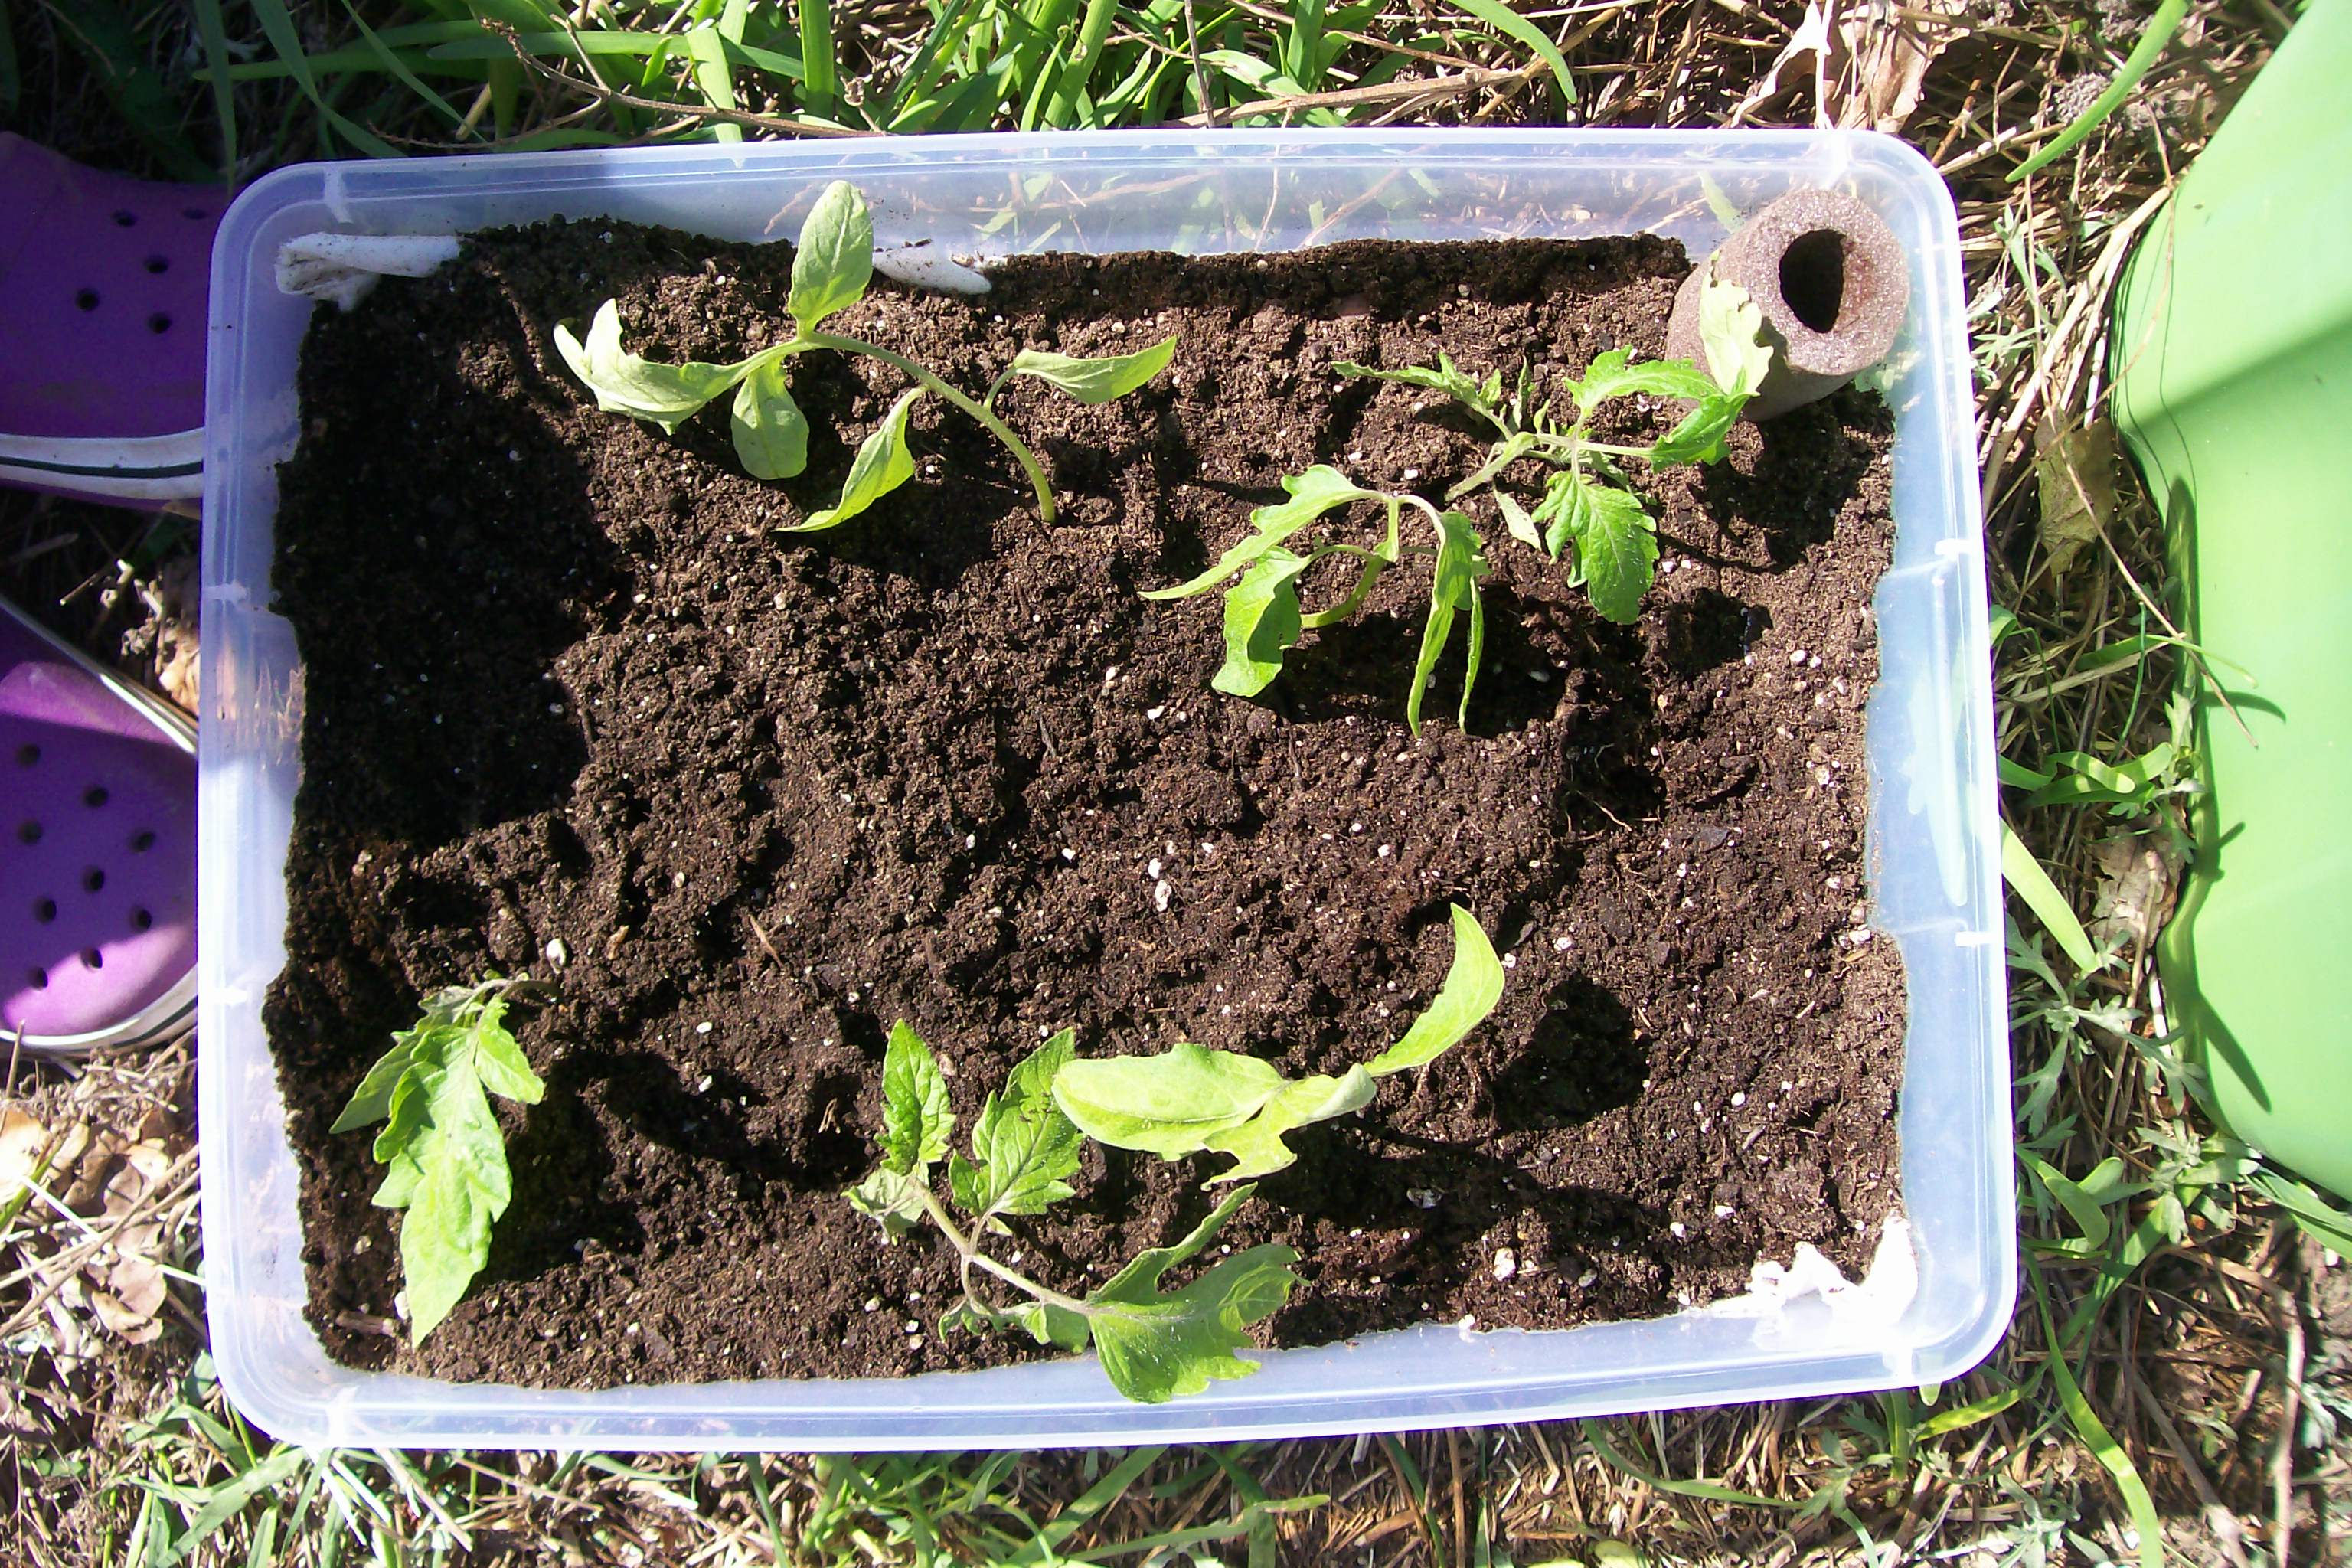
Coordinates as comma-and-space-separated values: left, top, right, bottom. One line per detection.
2112, 0, 2352, 1192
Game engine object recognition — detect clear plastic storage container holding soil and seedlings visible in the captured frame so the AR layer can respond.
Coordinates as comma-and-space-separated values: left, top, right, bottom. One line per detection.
200, 129, 2016, 1448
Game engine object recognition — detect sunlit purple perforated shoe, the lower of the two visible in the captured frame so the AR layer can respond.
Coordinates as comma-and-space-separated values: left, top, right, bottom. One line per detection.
0, 599, 195, 1050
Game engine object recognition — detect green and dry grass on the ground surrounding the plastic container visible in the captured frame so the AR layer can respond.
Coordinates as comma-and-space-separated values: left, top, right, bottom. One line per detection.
0, 0, 2352, 1568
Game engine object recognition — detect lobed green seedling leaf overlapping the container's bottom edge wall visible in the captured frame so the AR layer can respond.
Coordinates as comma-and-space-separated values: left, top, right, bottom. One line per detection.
1086, 1187, 1298, 1403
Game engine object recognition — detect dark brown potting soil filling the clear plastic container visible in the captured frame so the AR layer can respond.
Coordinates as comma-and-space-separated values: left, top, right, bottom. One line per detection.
268, 224, 1903, 1385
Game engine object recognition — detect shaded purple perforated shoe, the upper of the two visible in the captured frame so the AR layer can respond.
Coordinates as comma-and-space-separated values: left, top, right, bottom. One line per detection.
0, 132, 228, 508
